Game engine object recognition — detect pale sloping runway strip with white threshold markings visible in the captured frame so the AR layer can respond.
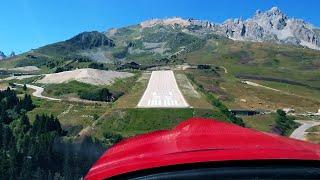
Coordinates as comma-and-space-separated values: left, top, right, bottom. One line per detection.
138, 71, 189, 108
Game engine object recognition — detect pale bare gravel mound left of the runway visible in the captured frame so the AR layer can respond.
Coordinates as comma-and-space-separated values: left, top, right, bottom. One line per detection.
37, 68, 134, 85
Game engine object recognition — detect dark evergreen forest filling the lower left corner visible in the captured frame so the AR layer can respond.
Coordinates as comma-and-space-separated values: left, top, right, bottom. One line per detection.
0, 88, 105, 179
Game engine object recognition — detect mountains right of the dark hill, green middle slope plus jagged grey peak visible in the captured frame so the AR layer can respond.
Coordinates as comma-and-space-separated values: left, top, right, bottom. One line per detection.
101, 7, 320, 61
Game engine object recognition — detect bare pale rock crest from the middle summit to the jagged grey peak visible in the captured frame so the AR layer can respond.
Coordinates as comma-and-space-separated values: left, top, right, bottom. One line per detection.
134, 7, 320, 50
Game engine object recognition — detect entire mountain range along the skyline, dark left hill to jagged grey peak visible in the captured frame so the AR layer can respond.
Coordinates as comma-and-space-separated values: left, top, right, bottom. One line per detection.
2, 7, 320, 67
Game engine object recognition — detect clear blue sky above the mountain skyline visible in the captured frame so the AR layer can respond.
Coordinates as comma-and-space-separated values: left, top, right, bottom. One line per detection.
0, 0, 320, 54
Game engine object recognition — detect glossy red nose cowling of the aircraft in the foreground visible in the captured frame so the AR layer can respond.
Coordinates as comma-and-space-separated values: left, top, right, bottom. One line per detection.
85, 118, 320, 180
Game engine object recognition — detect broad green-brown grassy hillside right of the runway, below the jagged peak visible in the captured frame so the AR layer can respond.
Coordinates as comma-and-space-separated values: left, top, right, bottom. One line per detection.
185, 39, 320, 112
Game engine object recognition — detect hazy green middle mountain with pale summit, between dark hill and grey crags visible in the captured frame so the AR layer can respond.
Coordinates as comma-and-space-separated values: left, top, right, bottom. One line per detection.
105, 18, 206, 63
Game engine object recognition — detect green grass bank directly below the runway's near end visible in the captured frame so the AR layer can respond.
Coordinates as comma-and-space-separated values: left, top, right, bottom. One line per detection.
94, 108, 226, 137
